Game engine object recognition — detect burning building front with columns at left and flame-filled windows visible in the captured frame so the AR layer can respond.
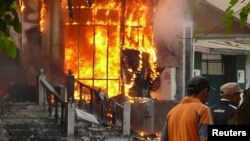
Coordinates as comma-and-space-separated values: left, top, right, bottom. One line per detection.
5, 0, 162, 100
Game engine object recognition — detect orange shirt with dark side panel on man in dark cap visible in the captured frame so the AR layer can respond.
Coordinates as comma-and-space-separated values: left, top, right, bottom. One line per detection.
166, 98, 213, 141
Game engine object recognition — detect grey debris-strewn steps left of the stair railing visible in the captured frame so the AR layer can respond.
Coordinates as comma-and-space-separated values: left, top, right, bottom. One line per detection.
0, 103, 65, 141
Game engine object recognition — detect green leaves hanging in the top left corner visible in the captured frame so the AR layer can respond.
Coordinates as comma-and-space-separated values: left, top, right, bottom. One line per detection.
0, 0, 22, 58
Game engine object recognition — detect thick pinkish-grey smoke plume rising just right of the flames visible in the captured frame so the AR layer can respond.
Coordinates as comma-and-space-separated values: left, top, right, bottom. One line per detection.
153, 0, 190, 68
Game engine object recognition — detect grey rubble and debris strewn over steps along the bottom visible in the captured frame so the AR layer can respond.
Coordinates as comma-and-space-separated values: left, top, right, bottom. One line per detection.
0, 95, 164, 141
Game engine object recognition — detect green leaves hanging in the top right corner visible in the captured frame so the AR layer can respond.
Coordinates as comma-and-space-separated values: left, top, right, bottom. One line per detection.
222, 0, 250, 34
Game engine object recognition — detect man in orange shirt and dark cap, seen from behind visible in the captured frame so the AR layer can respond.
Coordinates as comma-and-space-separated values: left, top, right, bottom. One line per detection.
161, 76, 213, 141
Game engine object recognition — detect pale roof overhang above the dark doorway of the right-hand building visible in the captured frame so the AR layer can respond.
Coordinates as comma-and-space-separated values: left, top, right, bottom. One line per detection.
194, 40, 250, 55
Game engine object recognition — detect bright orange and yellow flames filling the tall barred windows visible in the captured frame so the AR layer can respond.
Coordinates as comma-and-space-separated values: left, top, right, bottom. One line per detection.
37, 0, 157, 99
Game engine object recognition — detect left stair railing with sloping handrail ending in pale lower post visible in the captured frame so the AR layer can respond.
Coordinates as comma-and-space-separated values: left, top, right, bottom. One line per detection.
37, 69, 75, 135
